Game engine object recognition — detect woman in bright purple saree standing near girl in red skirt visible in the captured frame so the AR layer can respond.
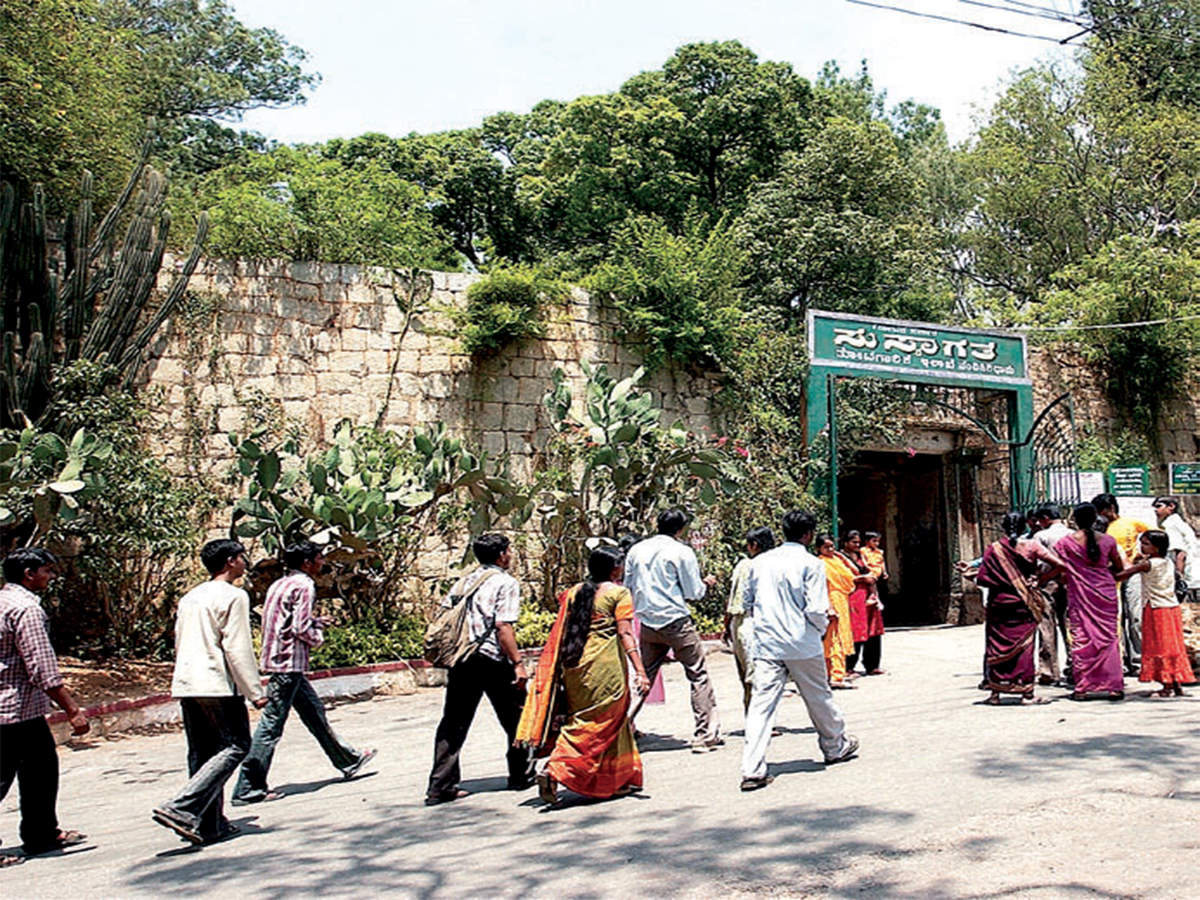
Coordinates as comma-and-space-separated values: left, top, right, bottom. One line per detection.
1054, 503, 1124, 700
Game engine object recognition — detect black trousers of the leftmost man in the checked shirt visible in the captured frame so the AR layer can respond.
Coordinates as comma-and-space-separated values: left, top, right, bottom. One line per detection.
0, 716, 59, 852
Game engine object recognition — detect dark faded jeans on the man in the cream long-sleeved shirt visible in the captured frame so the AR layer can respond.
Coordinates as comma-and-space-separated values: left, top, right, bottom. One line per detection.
162, 696, 250, 838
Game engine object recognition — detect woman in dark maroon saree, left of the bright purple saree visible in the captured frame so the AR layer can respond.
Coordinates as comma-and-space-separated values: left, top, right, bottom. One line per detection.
976, 512, 1062, 706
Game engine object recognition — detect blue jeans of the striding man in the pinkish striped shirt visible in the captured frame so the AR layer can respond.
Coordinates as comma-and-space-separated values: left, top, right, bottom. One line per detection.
233, 672, 360, 803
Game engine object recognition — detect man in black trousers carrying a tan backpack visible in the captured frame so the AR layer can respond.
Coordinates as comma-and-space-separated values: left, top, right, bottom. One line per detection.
425, 534, 533, 806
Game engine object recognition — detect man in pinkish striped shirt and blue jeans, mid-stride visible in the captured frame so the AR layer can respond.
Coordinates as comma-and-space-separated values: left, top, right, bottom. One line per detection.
233, 541, 376, 805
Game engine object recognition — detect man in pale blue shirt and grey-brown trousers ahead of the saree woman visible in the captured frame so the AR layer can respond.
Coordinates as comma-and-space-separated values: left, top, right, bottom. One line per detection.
625, 509, 725, 754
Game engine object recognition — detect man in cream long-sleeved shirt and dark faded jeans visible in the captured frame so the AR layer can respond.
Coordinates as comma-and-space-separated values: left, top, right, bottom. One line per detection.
154, 540, 266, 844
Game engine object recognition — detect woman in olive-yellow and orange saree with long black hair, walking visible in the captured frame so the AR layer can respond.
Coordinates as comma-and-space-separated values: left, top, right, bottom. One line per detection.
516, 547, 649, 803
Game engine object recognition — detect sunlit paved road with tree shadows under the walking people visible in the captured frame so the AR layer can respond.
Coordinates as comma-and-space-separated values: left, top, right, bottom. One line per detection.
0, 628, 1200, 898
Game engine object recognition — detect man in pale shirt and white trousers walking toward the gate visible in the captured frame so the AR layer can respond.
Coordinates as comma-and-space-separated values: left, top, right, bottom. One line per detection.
742, 510, 858, 791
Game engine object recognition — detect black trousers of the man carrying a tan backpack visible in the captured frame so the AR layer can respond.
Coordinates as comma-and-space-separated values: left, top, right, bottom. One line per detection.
427, 653, 530, 797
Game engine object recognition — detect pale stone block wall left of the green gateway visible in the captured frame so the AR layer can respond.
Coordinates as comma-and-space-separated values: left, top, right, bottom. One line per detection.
146, 262, 719, 482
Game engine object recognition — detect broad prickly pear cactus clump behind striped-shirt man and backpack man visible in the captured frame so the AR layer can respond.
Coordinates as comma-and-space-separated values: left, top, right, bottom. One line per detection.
229, 421, 528, 622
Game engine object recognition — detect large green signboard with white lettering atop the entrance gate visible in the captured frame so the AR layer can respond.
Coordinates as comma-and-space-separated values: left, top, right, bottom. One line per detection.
809, 310, 1030, 384
